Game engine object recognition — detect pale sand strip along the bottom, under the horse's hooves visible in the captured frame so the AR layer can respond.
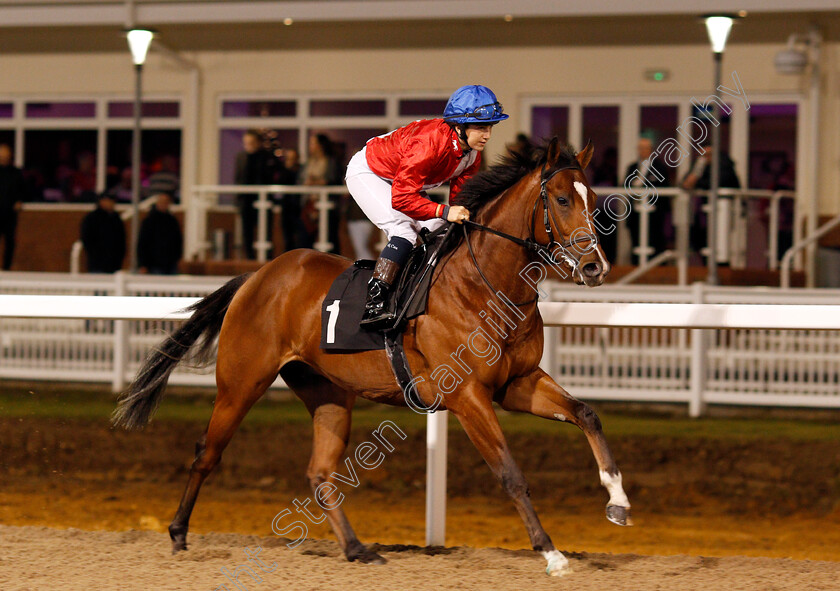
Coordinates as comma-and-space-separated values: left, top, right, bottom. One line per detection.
0, 526, 840, 591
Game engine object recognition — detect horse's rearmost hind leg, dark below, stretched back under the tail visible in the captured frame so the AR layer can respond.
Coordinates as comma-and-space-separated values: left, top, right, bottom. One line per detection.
169, 363, 276, 554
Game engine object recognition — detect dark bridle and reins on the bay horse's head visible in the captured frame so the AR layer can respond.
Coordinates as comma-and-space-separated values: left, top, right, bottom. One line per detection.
462, 164, 598, 306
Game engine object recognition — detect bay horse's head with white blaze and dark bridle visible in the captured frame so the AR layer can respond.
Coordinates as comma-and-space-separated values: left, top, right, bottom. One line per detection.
531, 138, 610, 287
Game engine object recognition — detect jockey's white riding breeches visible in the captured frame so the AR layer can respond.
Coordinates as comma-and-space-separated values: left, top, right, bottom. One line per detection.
345, 148, 445, 244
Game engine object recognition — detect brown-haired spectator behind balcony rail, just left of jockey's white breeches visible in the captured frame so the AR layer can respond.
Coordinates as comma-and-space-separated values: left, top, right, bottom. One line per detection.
302, 133, 341, 253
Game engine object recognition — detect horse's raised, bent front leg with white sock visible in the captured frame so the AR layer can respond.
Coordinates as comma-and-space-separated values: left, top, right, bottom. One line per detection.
501, 369, 633, 525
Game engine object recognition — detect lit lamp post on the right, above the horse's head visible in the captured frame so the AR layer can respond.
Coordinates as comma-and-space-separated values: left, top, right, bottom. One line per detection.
703, 14, 736, 285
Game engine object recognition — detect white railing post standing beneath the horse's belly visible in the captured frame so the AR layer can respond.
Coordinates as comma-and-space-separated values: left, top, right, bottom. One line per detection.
426, 410, 449, 546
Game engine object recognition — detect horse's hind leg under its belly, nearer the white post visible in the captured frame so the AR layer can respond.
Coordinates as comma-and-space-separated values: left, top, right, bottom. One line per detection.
280, 364, 385, 564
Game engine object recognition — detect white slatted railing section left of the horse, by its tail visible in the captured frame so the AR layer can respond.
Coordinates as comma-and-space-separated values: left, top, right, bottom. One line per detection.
0, 272, 229, 391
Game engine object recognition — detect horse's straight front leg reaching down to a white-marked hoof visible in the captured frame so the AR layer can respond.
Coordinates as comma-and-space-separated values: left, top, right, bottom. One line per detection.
447, 387, 569, 576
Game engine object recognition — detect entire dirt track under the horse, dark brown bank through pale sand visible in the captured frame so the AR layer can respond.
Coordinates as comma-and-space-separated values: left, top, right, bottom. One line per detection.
0, 410, 840, 591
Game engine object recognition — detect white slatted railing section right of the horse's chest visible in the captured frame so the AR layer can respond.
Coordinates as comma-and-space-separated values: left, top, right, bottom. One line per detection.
542, 283, 840, 416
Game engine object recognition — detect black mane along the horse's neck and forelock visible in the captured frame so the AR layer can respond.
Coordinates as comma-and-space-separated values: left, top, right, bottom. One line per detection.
456, 140, 577, 214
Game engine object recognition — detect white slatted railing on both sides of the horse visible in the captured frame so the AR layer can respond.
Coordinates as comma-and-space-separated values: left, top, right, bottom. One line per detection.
0, 273, 840, 415
